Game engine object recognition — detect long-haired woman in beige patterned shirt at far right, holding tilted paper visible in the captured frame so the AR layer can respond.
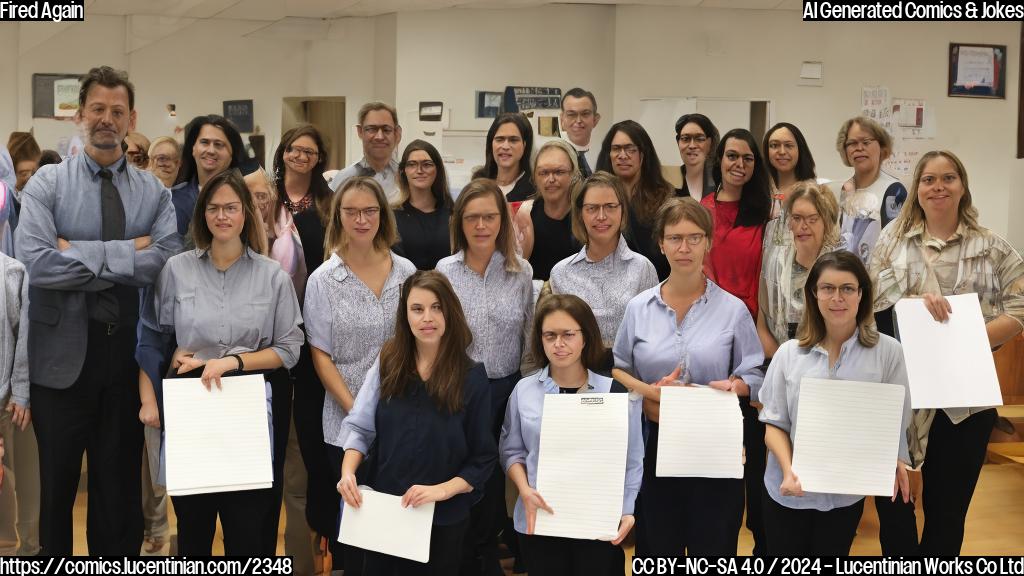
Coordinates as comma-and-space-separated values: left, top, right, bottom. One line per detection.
870, 151, 1024, 556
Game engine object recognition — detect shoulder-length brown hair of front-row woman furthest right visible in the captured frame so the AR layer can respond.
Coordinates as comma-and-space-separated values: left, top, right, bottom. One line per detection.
797, 250, 879, 348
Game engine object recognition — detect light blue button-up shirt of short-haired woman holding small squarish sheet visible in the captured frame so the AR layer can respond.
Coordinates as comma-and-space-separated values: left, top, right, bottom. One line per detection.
612, 280, 764, 400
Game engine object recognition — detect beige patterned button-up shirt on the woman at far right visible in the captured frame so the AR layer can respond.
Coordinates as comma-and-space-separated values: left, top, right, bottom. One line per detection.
869, 223, 1024, 461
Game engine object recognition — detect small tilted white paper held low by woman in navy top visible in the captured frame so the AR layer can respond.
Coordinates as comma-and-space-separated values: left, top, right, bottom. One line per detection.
338, 486, 434, 563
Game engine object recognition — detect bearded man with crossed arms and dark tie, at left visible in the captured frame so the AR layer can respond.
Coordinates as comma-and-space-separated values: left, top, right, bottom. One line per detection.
14, 67, 180, 556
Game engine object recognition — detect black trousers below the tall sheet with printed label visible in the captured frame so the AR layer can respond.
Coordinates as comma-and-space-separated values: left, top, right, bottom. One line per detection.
519, 534, 625, 576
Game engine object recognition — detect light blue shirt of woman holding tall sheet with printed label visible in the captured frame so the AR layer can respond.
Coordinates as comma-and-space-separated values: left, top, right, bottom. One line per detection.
498, 364, 638, 534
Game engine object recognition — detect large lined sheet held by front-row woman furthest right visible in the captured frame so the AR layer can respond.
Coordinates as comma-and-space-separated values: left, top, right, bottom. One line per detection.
793, 378, 904, 496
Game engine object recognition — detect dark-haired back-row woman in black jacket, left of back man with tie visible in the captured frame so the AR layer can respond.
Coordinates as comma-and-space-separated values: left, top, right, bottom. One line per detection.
473, 112, 537, 201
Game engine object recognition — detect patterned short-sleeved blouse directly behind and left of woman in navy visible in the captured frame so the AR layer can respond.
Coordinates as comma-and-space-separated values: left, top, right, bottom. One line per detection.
303, 252, 416, 446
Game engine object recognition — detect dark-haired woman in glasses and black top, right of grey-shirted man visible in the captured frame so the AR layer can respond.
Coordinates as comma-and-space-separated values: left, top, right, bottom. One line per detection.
393, 140, 453, 270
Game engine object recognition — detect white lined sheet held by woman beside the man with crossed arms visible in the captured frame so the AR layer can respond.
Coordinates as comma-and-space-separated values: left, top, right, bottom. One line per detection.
164, 374, 273, 496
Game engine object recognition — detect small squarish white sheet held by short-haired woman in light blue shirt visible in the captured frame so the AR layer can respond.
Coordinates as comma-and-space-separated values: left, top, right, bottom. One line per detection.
654, 386, 743, 478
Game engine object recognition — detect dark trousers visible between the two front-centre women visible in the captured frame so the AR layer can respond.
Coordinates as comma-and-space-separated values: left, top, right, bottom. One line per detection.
459, 371, 521, 576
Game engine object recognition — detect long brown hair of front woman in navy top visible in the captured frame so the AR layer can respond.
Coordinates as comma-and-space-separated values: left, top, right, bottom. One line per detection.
380, 270, 473, 414
